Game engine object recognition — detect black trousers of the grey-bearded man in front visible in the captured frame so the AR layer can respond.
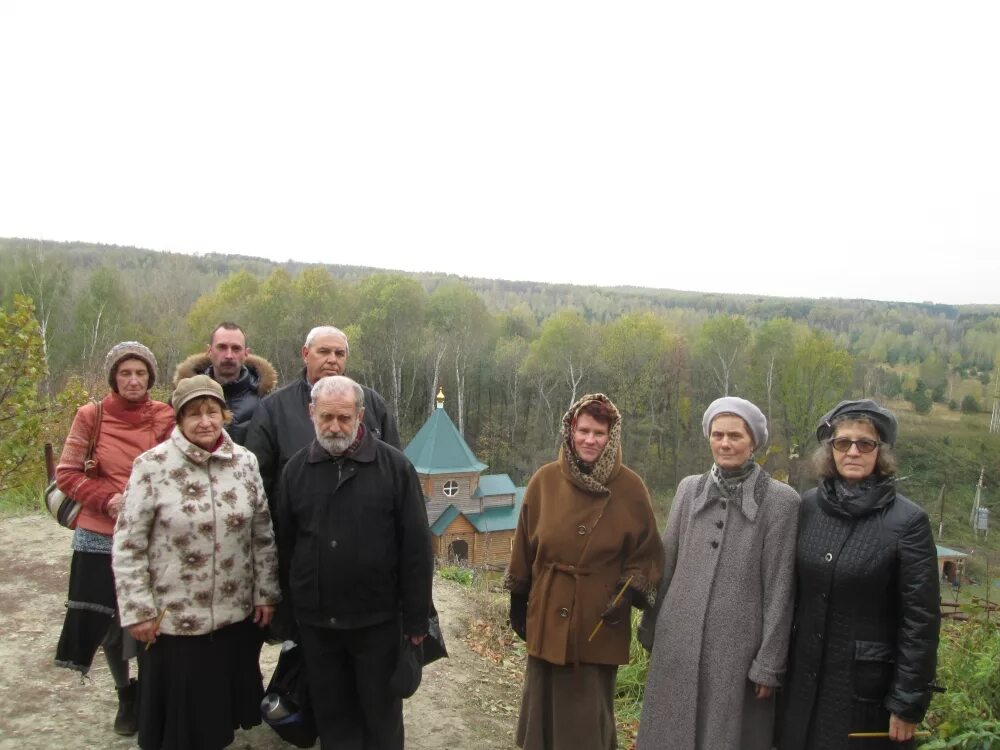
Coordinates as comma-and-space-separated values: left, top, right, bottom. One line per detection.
299, 620, 403, 750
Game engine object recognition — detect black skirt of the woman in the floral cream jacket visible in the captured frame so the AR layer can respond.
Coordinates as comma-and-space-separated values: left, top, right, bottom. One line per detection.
139, 620, 264, 750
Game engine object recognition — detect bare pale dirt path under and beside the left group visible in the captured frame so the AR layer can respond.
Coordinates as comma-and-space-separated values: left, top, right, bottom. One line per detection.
0, 516, 520, 750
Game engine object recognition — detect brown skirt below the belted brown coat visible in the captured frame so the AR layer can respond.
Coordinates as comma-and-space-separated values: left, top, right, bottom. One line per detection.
517, 656, 618, 750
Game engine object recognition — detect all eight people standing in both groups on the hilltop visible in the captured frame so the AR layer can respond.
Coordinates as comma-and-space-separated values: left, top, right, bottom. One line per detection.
56, 323, 940, 750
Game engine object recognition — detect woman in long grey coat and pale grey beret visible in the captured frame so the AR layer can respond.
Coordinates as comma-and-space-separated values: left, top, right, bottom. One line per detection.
637, 396, 799, 750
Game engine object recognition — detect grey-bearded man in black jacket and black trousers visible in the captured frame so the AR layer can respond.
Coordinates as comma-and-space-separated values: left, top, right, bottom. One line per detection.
277, 375, 433, 750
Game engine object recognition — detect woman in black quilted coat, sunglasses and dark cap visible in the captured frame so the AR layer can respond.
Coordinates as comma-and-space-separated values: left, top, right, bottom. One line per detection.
778, 400, 941, 750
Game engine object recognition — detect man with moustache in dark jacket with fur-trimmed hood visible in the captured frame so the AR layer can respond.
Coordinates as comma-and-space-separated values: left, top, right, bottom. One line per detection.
174, 321, 278, 445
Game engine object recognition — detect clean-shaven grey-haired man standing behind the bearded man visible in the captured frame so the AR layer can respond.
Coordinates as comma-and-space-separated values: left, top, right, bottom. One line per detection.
245, 326, 402, 514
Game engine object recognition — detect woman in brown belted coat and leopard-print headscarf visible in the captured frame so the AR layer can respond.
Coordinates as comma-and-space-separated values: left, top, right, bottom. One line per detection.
505, 393, 663, 750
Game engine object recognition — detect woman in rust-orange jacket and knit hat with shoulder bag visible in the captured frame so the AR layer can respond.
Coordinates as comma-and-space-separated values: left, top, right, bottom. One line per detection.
55, 341, 174, 735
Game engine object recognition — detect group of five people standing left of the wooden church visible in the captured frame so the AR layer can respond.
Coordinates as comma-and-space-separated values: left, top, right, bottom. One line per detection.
56, 323, 433, 750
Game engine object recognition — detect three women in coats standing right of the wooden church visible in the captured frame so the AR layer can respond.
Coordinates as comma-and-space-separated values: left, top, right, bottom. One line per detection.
505, 394, 940, 750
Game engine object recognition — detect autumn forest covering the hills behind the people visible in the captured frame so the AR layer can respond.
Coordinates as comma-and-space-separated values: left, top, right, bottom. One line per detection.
0, 239, 1000, 556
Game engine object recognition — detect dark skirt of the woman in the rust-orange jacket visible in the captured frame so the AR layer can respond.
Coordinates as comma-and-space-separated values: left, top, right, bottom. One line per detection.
56, 551, 122, 674
